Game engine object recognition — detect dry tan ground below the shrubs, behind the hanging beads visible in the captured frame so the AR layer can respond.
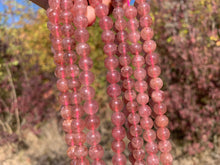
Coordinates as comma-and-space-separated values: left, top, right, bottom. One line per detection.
0, 120, 220, 165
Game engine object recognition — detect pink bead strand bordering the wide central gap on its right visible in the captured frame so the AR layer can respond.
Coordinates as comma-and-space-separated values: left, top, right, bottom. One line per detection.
95, 1, 126, 165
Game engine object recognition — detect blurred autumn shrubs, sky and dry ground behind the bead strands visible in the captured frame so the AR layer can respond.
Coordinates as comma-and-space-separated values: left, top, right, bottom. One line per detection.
0, 0, 220, 165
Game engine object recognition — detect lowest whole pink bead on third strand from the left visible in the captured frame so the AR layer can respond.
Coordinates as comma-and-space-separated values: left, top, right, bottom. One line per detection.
89, 144, 104, 160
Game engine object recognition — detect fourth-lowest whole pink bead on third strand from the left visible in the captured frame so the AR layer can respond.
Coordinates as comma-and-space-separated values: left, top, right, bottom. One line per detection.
83, 100, 99, 115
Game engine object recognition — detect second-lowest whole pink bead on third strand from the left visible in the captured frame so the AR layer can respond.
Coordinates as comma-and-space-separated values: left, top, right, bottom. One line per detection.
86, 130, 101, 145
